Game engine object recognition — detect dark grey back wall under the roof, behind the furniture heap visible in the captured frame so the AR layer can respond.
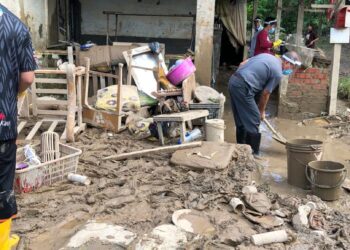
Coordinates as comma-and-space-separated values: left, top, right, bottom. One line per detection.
81, 0, 196, 39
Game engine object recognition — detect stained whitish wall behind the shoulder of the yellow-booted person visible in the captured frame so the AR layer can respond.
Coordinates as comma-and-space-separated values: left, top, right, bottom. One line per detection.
1, 0, 48, 50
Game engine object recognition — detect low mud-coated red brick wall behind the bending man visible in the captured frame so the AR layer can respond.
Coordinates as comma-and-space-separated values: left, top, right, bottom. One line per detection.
278, 68, 330, 119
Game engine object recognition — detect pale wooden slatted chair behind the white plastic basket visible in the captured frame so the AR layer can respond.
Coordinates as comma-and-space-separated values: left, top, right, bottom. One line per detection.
17, 64, 85, 142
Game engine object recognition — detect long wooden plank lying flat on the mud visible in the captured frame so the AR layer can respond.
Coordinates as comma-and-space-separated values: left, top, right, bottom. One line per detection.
102, 142, 202, 161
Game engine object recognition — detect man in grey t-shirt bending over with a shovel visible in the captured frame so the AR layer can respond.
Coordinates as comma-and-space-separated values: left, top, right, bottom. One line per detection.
229, 52, 301, 155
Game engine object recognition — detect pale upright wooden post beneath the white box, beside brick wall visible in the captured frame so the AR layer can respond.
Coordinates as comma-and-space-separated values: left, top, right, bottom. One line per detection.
328, 44, 341, 115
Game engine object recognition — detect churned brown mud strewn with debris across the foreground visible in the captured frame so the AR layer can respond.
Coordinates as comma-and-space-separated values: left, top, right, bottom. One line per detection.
15, 129, 350, 249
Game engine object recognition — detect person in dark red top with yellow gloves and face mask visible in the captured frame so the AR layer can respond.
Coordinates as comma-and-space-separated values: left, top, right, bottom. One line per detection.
254, 17, 282, 56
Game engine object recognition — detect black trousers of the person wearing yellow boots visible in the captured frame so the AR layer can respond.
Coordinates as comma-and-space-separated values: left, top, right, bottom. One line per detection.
0, 140, 17, 221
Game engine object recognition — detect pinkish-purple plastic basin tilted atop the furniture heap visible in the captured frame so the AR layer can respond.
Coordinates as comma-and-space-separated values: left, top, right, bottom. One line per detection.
166, 57, 196, 85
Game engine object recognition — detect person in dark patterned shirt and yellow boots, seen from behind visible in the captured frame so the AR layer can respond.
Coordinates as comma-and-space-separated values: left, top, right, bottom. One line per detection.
0, 4, 36, 250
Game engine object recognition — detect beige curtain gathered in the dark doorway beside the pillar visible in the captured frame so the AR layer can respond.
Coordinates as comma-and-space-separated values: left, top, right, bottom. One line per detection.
216, 0, 247, 49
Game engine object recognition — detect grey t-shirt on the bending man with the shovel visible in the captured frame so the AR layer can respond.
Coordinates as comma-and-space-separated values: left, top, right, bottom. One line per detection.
235, 53, 282, 93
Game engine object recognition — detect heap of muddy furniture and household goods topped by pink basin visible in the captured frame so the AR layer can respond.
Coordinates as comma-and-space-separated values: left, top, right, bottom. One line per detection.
83, 42, 225, 143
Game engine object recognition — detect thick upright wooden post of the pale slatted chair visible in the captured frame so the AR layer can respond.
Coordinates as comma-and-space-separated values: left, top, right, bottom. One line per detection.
66, 64, 77, 142
